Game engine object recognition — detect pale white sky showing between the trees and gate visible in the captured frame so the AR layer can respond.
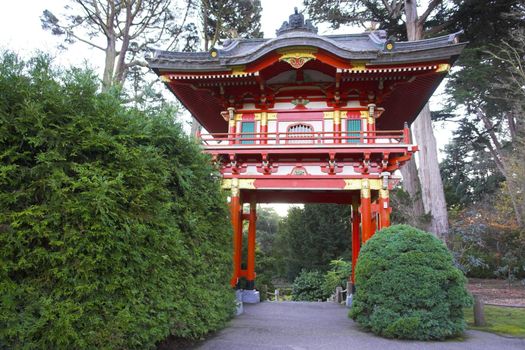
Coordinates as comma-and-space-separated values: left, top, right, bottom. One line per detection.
0, 0, 452, 215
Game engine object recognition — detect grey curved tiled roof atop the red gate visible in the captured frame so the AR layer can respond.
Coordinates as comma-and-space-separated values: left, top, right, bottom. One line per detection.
148, 28, 466, 71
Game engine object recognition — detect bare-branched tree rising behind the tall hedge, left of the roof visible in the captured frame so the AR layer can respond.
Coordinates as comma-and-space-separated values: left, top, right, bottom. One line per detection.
41, 0, 191, 89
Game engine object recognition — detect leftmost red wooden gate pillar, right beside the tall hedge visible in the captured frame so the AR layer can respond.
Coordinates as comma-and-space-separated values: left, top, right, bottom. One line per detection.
230, 179, 242, 287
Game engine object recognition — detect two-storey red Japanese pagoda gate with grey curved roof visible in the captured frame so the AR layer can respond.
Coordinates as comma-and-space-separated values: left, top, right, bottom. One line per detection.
149, 12, 465, 289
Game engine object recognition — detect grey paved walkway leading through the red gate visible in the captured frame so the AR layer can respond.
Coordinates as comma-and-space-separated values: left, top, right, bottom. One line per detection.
197, 302, 525, 350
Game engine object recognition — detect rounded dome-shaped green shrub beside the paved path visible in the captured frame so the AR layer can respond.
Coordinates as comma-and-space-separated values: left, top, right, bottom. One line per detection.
350, 225, 471, 340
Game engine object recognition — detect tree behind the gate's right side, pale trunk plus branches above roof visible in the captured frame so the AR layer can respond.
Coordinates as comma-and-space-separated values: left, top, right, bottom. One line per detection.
304, 0, 451, 237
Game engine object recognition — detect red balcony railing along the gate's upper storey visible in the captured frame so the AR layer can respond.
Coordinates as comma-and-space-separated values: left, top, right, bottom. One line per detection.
200, 127, 410, 148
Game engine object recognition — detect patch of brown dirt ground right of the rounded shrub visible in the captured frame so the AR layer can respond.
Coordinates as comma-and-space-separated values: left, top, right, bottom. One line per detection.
468, 278, 525, 307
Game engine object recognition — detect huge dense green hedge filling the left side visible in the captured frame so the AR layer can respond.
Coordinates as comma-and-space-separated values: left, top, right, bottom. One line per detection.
0, 54, 233, 349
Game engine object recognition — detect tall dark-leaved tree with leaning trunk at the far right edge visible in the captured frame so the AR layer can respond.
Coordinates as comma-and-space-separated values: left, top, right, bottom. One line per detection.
442, 0, 525, 227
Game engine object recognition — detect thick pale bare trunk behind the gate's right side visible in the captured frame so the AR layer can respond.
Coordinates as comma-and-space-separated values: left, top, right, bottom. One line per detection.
405, 0, 449, 238
